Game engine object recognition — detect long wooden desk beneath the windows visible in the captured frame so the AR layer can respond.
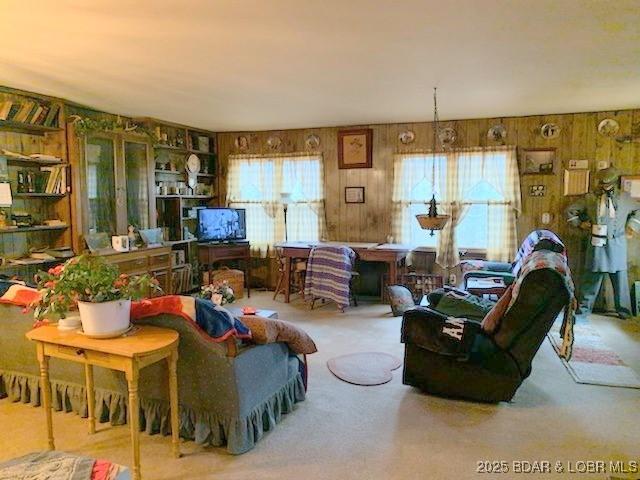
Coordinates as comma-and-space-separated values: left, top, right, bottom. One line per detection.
276, 242, 410, 303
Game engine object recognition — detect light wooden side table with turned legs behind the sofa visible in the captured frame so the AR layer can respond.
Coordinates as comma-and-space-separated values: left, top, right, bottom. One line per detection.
27, 325, 180, 480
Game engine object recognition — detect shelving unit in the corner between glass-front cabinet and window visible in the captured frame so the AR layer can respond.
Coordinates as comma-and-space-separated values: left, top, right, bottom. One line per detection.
135, 118, 219, 293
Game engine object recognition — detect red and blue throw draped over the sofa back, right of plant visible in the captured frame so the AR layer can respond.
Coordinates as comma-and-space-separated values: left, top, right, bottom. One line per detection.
131, 295, 251, 342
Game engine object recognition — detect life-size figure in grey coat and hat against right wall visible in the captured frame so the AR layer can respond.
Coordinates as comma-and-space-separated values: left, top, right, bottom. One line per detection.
567, 167, 640, 318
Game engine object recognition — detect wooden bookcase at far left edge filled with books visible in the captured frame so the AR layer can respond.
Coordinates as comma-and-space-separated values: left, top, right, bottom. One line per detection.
0, 87, 72, 274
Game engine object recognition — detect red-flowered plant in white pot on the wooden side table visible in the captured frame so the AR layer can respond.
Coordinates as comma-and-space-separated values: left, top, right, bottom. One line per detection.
34, 254, 162, 338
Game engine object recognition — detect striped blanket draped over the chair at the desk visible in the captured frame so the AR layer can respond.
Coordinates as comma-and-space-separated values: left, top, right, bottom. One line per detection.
304, 247, 356, 308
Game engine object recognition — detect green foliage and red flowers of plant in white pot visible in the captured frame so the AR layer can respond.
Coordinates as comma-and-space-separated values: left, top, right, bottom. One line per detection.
34, 254, 162, 320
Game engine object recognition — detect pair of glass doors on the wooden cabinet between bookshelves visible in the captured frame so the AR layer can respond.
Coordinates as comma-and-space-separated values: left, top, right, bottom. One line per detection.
78, 132, 156, 242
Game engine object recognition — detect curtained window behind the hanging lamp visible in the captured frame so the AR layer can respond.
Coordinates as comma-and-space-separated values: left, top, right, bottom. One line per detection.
393, 147, 520, 267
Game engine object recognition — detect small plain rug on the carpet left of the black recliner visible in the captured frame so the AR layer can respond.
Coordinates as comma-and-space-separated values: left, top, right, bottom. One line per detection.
327, 352, 402, 386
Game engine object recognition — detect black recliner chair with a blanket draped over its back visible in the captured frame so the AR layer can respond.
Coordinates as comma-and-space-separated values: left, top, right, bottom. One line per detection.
401, 251, 574, 402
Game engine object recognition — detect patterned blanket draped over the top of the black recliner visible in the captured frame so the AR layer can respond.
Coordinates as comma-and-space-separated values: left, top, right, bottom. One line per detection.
509, 250, 577, 360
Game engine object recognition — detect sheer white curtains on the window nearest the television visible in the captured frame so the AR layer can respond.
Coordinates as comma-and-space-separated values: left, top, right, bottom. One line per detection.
227, 154, 325, 256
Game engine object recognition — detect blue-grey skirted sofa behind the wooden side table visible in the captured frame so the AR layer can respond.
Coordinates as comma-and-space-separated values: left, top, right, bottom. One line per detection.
0, 304, 305, 454
